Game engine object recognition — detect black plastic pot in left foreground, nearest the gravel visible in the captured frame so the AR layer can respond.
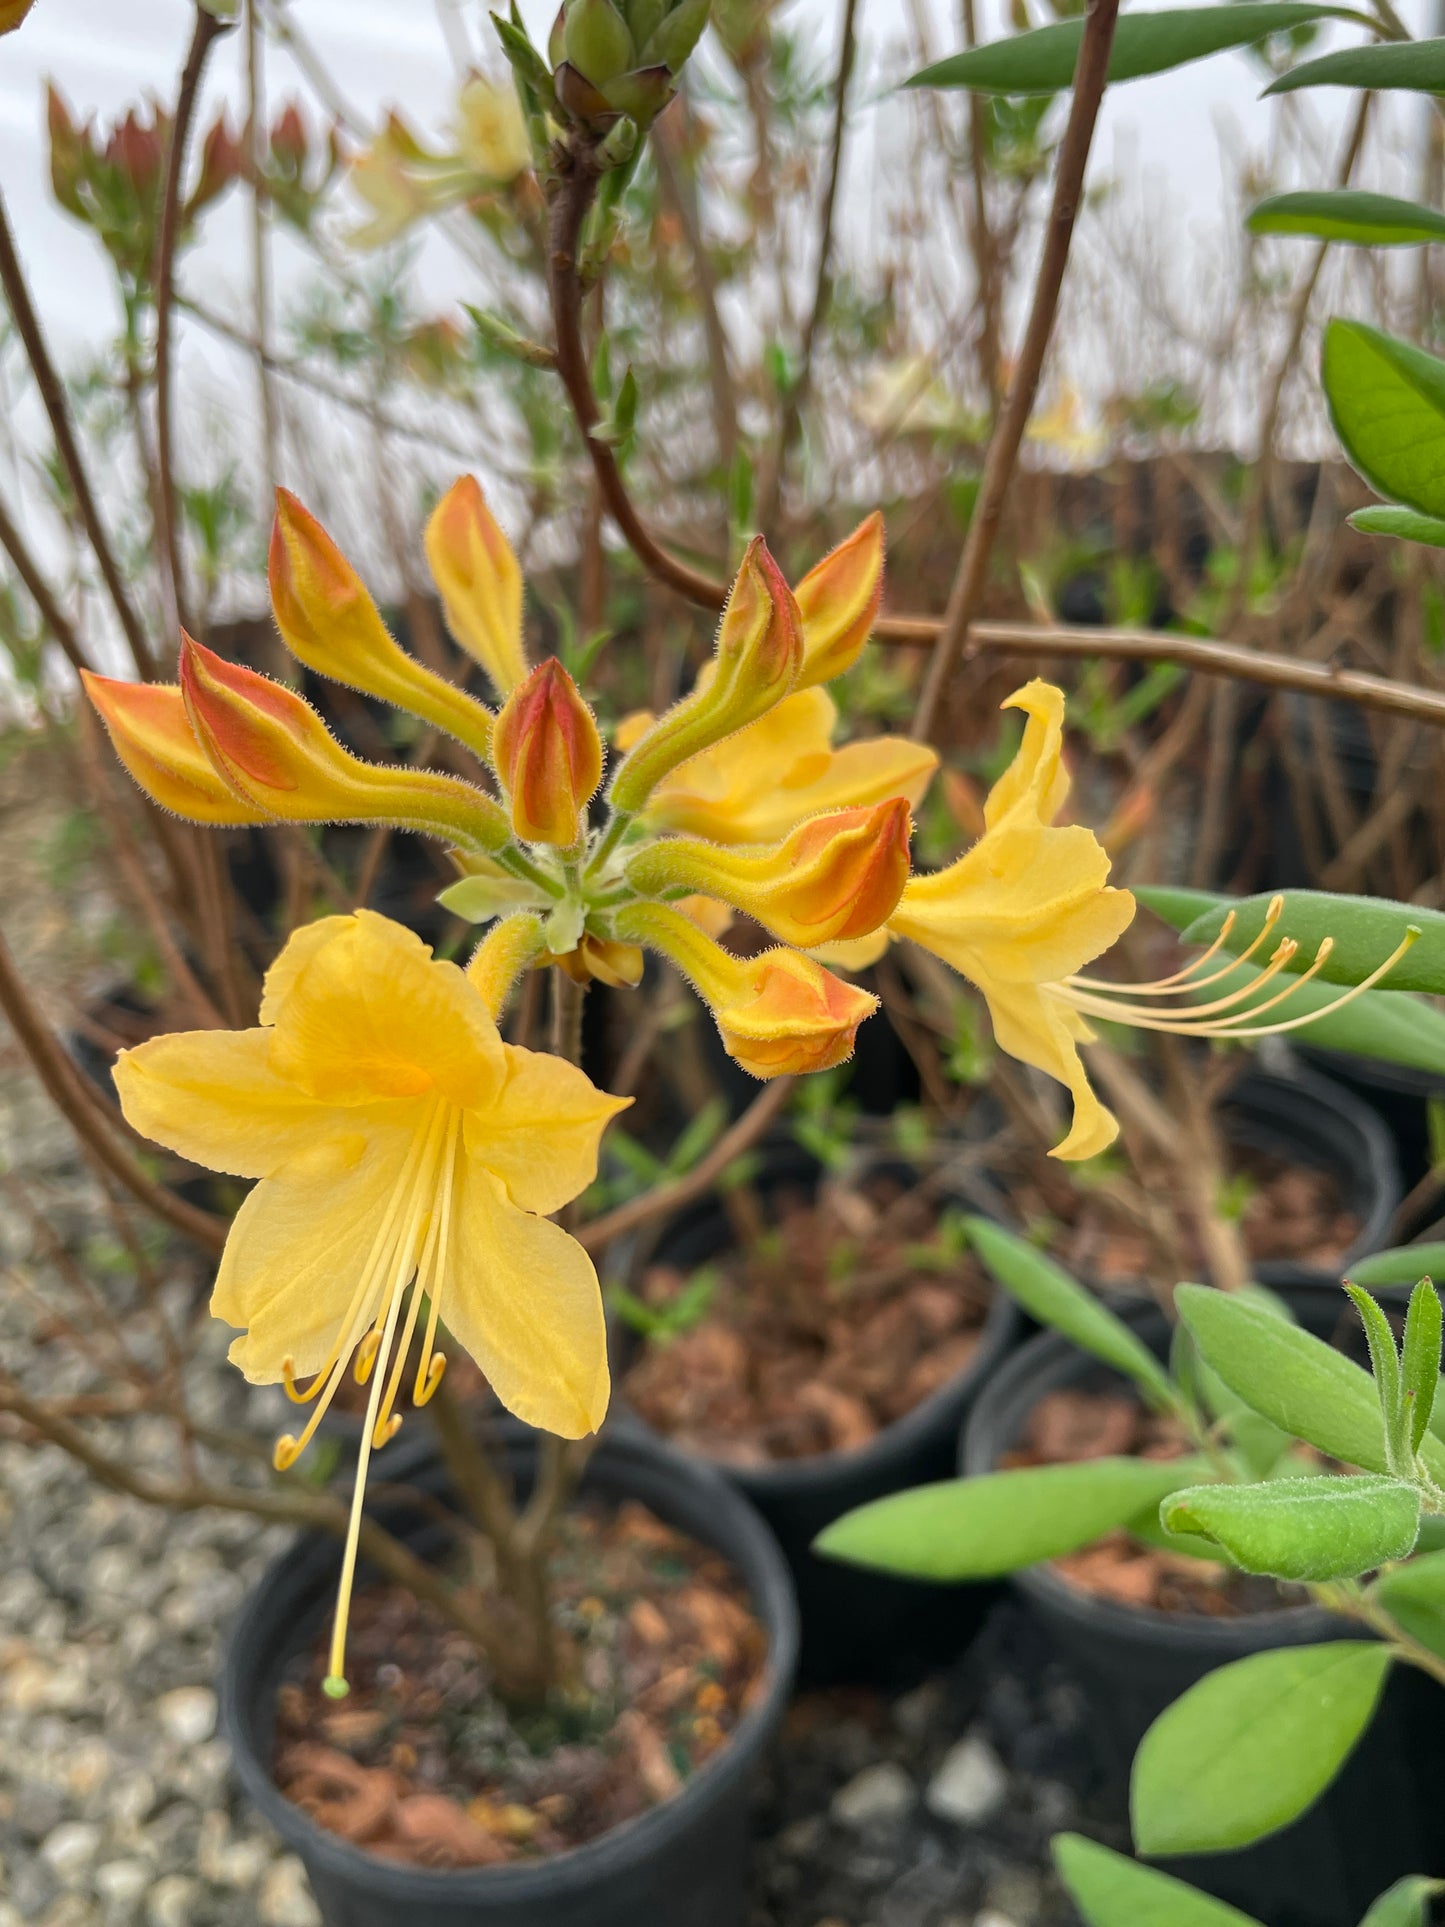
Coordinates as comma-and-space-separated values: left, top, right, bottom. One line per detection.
220, 1426, 798, 1927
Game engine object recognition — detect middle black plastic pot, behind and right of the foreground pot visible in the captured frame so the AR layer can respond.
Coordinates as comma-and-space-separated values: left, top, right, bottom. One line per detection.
618, 1145, 1021, 1686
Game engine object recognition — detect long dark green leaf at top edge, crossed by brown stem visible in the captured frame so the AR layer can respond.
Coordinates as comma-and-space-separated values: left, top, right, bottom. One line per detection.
907, 0, 1370, 94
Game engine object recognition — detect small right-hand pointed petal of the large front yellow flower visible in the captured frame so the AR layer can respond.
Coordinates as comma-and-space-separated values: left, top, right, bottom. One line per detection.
464, 1044, 632, 1212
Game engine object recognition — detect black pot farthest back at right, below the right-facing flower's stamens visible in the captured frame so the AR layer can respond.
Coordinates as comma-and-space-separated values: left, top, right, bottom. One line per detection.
1220, 1060, 1401, 1285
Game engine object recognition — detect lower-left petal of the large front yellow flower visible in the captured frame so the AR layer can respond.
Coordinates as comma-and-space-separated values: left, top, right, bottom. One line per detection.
210, 1104, 418, 1386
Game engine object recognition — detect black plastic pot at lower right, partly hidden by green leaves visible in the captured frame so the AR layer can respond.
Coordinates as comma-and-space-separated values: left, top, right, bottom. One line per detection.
961, 1285, 1445, 1927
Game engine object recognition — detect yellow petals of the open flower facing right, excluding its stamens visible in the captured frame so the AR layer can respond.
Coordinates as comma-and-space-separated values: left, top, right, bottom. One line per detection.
888, 680, 1135, 1158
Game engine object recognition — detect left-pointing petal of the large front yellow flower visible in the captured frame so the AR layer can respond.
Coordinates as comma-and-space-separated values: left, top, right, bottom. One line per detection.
116, 1031, 335, 1177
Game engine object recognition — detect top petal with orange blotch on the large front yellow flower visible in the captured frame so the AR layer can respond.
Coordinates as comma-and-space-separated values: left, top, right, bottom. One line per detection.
272, 910, 505, 1104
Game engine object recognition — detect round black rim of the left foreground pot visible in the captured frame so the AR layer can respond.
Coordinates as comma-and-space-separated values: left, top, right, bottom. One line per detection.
220, 1420, 800, 1906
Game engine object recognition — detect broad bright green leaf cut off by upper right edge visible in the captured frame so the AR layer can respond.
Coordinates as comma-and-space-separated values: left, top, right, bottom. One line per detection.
1320, 321, 1445, 516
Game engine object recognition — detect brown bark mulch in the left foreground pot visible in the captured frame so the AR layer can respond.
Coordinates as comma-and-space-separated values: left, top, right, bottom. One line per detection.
274, 1503, 767, 1869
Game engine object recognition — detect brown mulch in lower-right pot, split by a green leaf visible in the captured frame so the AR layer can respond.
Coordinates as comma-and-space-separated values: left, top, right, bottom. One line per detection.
1002, 1389, 1308, 1619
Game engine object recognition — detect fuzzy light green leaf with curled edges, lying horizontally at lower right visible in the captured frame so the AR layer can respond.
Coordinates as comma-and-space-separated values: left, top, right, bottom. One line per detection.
1160, 1474, 1420, 1580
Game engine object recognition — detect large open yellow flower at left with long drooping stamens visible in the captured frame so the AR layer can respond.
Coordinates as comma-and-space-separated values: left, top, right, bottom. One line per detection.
116, 910, 630, 1690
